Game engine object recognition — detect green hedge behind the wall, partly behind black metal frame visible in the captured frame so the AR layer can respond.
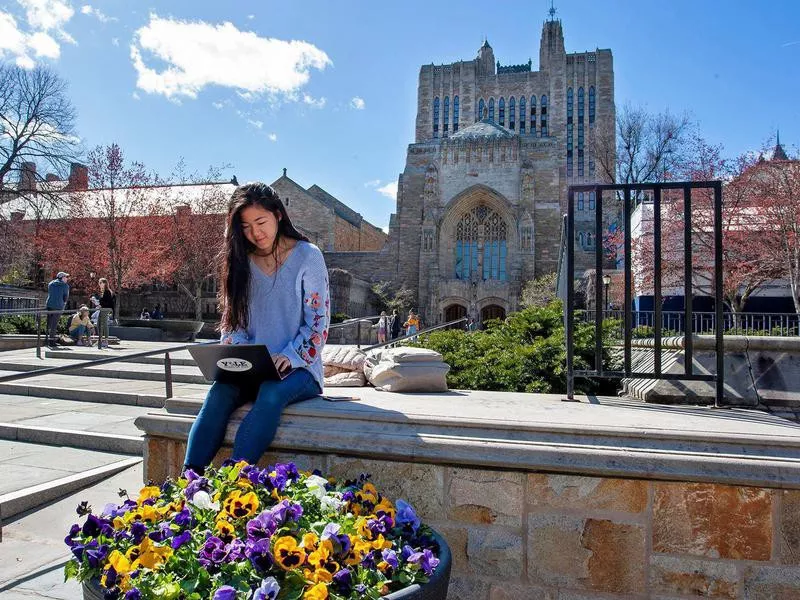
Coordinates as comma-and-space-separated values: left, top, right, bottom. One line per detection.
417, 301, 619, 395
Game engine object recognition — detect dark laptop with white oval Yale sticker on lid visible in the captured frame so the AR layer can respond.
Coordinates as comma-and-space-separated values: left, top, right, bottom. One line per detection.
189, 344, 292, 385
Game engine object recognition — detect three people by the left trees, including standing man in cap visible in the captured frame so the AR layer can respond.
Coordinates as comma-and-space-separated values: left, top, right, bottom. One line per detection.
45, 271, 117, 348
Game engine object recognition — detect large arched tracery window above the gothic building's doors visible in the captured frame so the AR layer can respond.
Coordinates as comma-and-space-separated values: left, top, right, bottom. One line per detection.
455, 206, 508, 281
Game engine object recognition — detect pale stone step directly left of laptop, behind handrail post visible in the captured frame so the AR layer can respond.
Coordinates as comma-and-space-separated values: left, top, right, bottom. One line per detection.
2, 355, 207, 383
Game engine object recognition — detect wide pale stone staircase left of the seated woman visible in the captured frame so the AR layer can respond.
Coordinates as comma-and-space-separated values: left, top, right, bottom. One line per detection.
0, 342, 208, 524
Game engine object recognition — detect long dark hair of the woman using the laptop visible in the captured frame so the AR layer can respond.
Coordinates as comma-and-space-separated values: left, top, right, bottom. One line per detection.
217, 182, 309, 332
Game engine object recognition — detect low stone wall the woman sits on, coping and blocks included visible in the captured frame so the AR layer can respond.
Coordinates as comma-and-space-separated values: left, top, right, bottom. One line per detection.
137, 388, 800, 600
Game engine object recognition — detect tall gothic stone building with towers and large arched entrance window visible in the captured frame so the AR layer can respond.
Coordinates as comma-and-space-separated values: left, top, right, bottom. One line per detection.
328, 19, 615, 324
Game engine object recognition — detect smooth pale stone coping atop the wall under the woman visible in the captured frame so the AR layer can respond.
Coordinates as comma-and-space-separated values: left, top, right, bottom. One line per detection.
136, 388, 800, 488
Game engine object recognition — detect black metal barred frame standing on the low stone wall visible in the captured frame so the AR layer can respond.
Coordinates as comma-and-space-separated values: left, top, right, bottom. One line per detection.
565, 181, 725, 407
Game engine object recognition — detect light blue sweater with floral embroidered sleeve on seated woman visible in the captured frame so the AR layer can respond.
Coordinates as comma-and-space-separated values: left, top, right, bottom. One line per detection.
222, 242, 330, 391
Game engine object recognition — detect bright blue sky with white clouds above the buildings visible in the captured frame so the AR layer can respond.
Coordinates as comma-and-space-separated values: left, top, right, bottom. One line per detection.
0, 0, 800, 227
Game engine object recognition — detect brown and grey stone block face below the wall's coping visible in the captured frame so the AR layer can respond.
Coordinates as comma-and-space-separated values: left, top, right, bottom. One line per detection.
147, 438, 800, 600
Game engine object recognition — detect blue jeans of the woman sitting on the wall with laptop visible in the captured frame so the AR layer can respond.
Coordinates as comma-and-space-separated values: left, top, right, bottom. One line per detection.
183, 369, 320, 471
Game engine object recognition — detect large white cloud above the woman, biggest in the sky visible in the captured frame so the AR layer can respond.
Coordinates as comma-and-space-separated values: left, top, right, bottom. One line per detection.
131, 15, 332, 100
